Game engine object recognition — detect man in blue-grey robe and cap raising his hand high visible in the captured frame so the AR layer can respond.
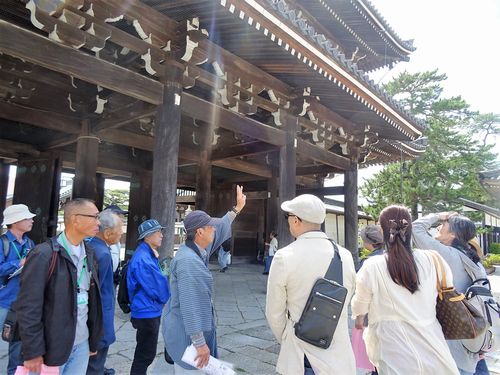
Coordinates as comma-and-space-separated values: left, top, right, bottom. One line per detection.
163, 186, 246, 375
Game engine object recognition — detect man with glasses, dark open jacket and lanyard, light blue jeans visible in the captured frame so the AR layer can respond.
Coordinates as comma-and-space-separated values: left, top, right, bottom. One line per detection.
16, 198, 102, 375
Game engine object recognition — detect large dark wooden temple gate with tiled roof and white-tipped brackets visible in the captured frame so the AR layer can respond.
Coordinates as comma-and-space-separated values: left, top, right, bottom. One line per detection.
0, 0, 423, 264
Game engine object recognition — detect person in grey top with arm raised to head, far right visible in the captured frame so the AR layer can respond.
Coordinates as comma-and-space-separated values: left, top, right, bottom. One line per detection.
413, 212, 486, 375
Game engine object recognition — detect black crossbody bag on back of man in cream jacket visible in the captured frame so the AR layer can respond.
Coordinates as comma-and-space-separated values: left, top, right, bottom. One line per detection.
294, 240, 347, 349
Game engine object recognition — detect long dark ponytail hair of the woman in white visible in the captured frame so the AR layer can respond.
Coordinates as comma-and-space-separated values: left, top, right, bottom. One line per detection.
379, 206, 420, 294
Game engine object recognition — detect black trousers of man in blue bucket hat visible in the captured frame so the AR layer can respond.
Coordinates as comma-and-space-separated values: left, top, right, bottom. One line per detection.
130, 317, 160, 375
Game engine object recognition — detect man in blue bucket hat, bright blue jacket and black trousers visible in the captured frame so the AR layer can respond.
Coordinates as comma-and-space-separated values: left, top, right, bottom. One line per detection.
127, 219, 170, 375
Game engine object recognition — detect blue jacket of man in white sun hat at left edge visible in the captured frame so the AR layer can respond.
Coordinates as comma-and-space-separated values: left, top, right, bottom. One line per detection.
0, 230, 34, 309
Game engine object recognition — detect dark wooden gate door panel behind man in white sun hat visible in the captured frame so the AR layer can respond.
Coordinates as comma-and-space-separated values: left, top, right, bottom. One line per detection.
13, 153, 62, 243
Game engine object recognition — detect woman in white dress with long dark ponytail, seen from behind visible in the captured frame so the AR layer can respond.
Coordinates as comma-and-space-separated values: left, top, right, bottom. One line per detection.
351, 206, 459, 375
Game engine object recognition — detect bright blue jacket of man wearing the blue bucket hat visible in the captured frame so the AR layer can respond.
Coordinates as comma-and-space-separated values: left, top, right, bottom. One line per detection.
127, 242, 170, 319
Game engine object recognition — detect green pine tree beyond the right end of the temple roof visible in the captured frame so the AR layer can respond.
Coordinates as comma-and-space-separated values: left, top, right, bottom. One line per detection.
361, 70, 500, 220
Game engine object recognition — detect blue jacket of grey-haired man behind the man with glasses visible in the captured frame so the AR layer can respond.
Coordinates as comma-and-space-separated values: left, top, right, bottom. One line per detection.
87, 237, 116, 350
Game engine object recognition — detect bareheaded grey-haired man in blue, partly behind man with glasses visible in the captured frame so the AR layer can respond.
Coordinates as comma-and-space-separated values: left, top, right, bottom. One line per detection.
87, 210, 123, 375
